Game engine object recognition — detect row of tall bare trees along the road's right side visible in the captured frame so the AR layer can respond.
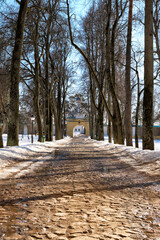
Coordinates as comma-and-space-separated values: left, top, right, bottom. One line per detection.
67, 0, 160, 149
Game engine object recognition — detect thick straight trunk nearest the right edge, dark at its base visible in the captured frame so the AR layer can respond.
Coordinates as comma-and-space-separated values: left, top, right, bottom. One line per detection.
143, 0, 154, 150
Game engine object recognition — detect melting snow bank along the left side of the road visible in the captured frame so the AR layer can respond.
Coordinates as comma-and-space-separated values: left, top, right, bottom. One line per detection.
0, 135, 70, 179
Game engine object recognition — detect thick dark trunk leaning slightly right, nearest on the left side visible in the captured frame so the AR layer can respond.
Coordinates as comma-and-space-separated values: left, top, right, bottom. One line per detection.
7, 0, 28, 146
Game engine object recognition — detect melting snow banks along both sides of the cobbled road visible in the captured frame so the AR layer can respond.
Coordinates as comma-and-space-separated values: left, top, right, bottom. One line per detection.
0, 135, 160, 179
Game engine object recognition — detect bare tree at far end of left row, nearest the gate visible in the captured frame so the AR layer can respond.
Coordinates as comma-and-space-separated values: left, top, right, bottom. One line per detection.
50, 36, 70, 140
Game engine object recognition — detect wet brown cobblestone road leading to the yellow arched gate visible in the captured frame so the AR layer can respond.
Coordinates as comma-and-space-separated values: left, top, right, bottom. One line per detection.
0, 138, 160, 240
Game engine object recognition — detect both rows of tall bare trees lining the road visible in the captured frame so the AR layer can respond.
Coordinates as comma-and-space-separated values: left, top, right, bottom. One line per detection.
0, 0, 160, 149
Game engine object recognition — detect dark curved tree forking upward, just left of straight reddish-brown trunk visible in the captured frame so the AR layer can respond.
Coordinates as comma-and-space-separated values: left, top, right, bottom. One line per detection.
106, 0, 127, 143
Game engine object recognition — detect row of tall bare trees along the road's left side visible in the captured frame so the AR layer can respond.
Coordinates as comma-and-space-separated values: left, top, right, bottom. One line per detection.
1, 0, 72, 146
